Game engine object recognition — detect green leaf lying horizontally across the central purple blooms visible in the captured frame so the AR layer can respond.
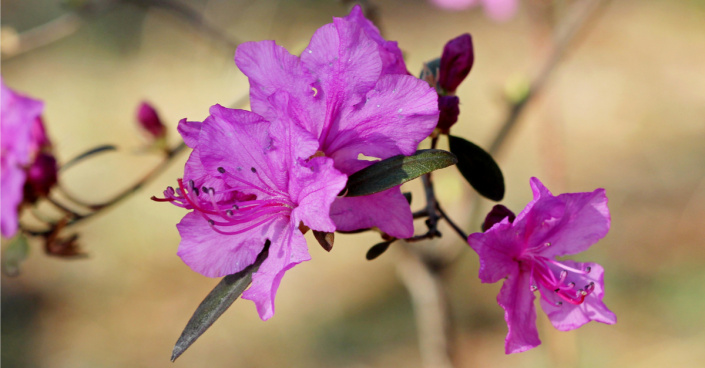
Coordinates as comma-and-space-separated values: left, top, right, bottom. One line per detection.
343, 149, 458, 197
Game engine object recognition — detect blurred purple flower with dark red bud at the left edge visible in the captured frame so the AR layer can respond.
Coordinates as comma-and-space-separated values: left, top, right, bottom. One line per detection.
0, 79, 58, 237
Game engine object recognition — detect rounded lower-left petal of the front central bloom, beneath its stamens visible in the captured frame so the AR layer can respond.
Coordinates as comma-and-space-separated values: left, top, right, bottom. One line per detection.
176, 212, 272, 277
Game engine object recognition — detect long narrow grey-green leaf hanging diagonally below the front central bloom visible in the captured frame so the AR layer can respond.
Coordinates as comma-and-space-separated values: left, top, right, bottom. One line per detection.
171, 240, 270, 362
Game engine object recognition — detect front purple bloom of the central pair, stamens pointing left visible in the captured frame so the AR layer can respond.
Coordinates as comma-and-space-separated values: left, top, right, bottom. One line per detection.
159, 95, 346, 320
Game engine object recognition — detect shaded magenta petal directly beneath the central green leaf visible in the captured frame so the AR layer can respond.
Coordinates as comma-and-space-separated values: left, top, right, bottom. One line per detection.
330, 187, 414, 238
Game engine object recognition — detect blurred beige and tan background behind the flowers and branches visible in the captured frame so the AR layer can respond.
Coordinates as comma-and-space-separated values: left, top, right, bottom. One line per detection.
2, 0, 705, 368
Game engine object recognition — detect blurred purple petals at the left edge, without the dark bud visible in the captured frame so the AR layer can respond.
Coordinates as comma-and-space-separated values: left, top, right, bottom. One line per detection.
0, 79, 46, 237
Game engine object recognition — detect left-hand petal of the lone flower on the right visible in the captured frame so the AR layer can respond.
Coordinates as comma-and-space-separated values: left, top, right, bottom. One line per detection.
468, 218, 524, 283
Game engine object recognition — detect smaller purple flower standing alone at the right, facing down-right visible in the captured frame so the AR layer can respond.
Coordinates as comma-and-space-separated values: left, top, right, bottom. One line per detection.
468, 178, 617, 354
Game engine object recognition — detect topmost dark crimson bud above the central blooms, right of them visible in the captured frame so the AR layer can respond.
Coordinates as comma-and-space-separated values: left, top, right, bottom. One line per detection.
438, 33, 475, 94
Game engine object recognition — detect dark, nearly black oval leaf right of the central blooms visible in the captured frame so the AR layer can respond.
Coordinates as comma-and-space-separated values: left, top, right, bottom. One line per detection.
448, 135, 504, 201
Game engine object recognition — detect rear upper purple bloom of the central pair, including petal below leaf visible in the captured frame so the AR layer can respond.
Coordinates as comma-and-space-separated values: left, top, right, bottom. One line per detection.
235, 6, 438, 238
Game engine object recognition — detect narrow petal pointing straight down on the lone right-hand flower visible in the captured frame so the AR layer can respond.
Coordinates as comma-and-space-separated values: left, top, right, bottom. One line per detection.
497, 270, 541, 354
